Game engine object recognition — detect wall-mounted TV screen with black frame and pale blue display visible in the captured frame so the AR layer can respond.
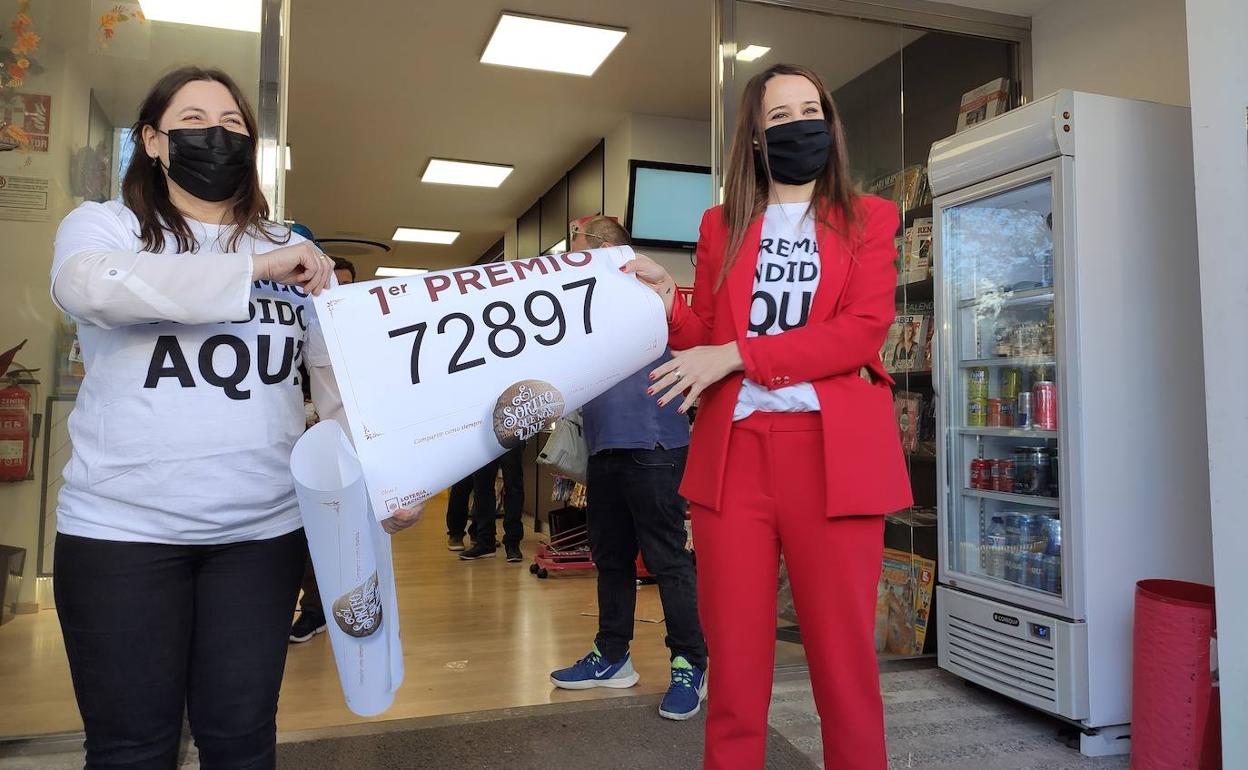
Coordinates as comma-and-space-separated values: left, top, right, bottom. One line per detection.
628, 160, 714, 248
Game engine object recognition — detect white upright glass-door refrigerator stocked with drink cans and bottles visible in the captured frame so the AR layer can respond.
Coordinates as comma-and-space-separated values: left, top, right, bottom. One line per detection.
930, 91, 1212, 755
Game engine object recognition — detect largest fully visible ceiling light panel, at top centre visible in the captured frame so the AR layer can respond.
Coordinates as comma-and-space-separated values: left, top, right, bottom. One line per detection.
480, 14, 628, 77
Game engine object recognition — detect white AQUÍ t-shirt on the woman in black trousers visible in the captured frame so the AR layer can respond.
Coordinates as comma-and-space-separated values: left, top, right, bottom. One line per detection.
52, 201, 328, 544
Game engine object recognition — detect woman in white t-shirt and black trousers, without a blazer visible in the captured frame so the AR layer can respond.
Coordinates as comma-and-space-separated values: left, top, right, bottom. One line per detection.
52, 67, 419, 770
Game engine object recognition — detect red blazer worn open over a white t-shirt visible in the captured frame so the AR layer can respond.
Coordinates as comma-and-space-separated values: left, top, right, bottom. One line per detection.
669, 196, 914, 517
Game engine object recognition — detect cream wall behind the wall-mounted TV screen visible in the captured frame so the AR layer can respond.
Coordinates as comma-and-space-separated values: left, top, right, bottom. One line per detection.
604, 114, 710, 286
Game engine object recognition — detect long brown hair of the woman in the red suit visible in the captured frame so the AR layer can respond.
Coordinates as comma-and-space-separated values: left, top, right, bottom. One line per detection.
715, 64, 857, 288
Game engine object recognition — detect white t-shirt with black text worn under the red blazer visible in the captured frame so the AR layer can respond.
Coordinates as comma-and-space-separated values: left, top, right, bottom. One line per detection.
733, 203, 820, 421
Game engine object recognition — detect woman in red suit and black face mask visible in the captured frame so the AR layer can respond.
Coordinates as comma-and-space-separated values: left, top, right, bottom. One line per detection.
625, 65, 912, 770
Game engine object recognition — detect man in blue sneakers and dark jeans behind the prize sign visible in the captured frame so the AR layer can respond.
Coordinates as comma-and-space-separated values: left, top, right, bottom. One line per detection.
550, 216, 706, 720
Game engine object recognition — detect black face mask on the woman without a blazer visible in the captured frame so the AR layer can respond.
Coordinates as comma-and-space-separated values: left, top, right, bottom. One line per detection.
163, 126, 256, 203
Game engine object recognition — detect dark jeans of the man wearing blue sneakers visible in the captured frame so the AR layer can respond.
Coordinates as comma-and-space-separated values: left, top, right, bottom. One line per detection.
587, 447, 706, 669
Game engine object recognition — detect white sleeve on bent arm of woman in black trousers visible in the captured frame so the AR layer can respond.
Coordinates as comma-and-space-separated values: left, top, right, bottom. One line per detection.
52, 205, 252, 328
